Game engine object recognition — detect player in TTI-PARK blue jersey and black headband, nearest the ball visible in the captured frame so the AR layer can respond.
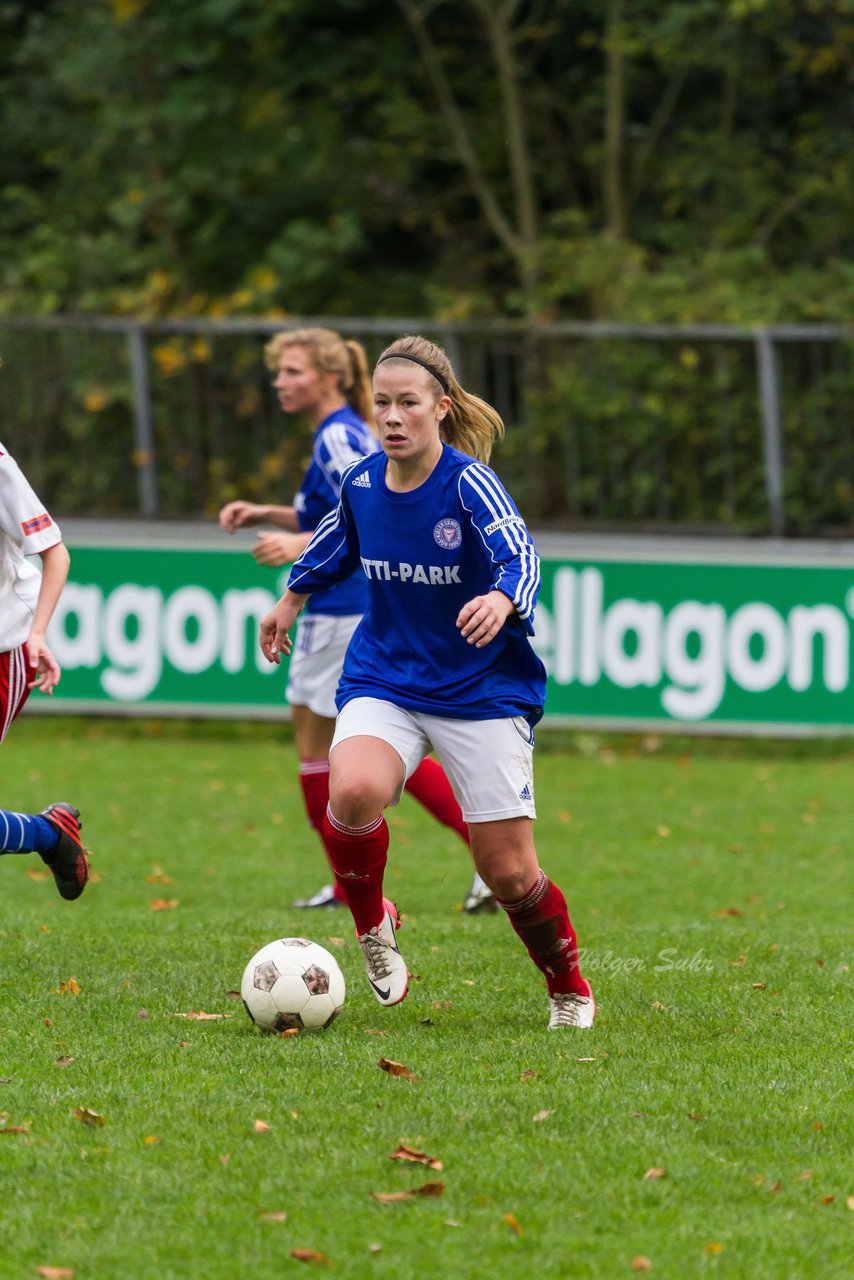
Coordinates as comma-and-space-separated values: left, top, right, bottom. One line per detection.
261, 337, 595, 1029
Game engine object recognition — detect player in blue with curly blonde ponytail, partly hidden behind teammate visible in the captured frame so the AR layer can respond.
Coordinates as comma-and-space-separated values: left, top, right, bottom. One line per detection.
219, 328, 494, 911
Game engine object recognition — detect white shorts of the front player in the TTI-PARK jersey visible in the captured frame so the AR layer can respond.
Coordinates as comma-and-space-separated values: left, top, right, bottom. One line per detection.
330, 698, 536, 823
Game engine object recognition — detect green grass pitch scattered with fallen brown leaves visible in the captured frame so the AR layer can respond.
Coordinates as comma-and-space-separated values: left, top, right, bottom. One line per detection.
0, 717, 854, 1280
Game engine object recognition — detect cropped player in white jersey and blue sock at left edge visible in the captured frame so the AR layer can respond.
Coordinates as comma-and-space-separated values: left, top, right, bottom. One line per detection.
0, 444, 88, 899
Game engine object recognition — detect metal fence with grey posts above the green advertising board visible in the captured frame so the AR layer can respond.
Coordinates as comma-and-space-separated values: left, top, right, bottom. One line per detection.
0, 316, 854, 536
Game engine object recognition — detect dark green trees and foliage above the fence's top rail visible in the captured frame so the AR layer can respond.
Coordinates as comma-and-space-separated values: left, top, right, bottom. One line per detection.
0, 0, 854, 321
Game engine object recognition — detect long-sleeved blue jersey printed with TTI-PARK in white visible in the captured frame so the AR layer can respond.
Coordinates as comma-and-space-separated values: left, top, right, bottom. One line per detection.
288, 444, 545, 724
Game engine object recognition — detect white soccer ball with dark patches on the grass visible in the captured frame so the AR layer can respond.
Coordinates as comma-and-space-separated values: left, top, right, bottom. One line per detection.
241, 938, 344, 1032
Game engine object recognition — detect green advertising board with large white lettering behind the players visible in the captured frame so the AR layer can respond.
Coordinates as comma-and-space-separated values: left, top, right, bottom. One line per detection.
31, 544, 854, 733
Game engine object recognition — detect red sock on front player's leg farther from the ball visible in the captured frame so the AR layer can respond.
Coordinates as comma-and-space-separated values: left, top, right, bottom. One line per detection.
498, 872, 590, 996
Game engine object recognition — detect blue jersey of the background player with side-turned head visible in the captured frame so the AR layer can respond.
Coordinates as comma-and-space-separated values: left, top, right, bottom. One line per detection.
293, 404, 379, 617
